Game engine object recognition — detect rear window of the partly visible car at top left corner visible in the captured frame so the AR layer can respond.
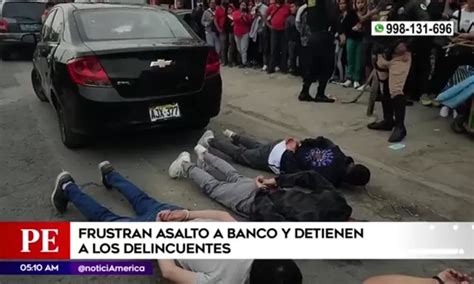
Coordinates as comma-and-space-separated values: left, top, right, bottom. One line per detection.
2, 2, 46, 23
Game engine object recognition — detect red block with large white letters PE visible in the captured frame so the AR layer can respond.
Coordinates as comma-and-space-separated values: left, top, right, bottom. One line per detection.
0, 222, 71, 260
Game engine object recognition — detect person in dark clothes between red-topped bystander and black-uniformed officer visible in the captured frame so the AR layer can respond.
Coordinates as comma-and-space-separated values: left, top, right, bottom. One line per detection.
285, 3, 300, 76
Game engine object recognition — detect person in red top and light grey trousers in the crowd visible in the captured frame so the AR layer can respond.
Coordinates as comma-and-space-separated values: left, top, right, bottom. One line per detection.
232, 2, 252, 68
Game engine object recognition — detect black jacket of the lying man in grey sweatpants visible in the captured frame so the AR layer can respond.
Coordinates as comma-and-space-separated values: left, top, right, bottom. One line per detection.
250, 189, 352, 222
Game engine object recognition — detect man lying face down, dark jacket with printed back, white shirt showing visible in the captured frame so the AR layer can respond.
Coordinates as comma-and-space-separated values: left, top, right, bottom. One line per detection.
195, 130, 370, 186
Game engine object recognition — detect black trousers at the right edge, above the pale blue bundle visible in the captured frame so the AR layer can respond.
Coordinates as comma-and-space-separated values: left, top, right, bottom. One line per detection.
430, 50, 474, 94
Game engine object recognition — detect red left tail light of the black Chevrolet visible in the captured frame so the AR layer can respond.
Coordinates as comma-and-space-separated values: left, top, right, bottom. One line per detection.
67, 56, 111, 87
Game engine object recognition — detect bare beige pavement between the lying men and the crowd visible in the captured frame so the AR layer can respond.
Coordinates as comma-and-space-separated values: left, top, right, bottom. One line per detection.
218, 68, 474, 221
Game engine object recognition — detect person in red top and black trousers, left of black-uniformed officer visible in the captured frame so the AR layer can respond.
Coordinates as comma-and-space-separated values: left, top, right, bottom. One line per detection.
267, 0, 290, 74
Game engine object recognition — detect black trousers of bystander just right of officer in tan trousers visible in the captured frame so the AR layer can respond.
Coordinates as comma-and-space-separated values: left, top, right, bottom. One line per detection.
405, 46, 431, 100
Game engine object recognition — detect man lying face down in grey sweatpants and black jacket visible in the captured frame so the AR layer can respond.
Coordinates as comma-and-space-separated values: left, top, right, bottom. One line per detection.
169, 144, 352, 221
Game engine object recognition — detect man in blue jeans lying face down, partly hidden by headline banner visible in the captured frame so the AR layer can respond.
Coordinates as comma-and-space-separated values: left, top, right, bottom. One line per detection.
51, 161, 302, 284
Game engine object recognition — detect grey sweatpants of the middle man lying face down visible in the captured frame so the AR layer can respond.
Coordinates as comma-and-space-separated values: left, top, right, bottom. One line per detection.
184, 153, 258, 218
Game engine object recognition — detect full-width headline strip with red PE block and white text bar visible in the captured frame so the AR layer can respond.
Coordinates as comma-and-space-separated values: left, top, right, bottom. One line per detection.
0, 222, 474, 260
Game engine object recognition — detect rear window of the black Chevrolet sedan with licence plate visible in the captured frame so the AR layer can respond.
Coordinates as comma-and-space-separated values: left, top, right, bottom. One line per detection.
74, 8, 192, 41
